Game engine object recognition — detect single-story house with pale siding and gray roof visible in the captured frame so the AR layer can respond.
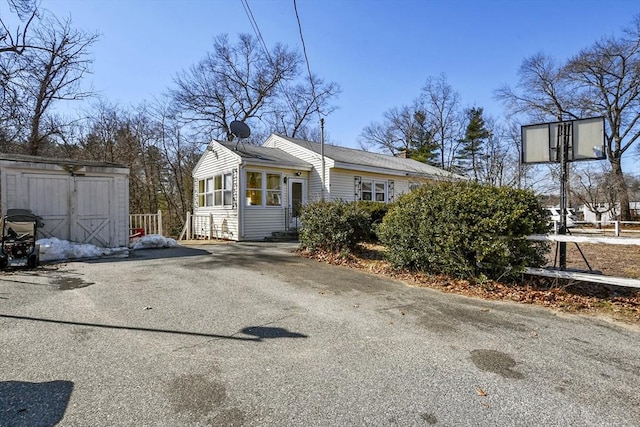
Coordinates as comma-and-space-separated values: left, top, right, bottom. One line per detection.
192, 134, 463, 240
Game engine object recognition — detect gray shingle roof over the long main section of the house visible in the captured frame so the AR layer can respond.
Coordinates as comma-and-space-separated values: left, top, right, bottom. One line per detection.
278, 135, 465, 179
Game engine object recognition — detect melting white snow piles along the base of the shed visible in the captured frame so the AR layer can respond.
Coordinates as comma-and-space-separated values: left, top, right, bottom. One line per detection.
37, 234, 179, 262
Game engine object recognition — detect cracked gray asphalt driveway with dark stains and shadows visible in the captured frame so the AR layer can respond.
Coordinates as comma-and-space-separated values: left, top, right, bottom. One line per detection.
0, 243, 640, 426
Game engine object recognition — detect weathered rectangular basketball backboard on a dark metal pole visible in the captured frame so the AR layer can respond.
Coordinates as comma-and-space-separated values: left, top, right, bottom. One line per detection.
521, 117, 606, 163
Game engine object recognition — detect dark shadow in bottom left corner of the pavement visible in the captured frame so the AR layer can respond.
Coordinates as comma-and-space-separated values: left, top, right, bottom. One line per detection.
0, 381, 73, 427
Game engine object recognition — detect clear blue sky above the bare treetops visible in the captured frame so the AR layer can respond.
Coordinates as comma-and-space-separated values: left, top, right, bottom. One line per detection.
41, 0, 640, 171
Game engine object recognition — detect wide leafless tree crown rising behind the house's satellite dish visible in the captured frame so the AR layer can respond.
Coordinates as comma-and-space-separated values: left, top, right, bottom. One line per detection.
170, 34, 339, 140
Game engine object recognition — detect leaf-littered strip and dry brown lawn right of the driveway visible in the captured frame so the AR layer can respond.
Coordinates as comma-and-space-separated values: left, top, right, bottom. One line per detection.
302, 244, 640, 325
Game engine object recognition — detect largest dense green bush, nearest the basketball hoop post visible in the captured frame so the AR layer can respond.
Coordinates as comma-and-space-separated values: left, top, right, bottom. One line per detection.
378, 182, 549, 279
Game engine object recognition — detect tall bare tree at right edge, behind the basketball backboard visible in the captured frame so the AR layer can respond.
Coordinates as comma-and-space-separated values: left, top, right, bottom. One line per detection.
496, 15, 640, 220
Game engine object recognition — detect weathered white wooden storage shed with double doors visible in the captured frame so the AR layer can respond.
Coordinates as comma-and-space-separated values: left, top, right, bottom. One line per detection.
0, 153, 129, 247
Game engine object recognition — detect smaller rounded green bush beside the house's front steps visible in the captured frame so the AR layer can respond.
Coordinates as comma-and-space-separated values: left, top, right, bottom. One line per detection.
299, 201, 371, 253
